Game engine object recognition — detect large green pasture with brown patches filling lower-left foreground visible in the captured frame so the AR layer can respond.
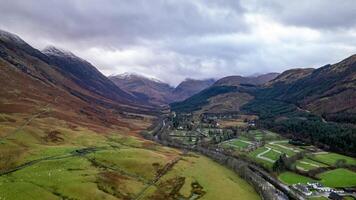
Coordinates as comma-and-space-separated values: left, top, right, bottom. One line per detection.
0, 113, 259, 200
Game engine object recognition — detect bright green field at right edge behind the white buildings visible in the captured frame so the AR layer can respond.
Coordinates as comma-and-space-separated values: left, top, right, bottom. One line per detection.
318, 168, 356, 187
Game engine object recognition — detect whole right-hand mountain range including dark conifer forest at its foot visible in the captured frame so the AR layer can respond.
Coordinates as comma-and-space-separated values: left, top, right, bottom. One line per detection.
171, 55, 356, 156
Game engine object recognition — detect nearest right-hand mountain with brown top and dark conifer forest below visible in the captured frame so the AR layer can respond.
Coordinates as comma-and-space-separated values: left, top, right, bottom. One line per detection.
242, 55, 356, 156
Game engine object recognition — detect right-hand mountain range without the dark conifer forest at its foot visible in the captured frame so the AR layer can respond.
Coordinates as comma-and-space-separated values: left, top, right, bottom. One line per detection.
172, 55, 356, 123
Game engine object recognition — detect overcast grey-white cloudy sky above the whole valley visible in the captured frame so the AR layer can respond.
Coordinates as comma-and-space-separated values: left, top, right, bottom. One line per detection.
0, 0, 356, 85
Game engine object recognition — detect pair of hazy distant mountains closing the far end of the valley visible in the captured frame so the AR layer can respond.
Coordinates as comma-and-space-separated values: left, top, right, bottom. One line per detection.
109, 73, 215, 105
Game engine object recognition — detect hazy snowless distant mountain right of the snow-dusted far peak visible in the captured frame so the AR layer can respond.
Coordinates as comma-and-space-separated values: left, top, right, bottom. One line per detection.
172, 79, 215, 102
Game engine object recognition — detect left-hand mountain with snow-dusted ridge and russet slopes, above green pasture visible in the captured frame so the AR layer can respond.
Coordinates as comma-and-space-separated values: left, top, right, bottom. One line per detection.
0, 31, 158, 130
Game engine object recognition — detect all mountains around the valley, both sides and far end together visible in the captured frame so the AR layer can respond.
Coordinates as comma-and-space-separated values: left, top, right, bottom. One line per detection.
0, 28, 356, 154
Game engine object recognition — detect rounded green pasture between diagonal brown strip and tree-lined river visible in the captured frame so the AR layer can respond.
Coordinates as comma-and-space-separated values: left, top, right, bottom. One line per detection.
140, 156, 259, 200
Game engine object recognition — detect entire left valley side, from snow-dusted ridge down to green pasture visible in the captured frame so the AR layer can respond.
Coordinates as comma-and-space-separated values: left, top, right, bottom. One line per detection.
0, 28, 259, 200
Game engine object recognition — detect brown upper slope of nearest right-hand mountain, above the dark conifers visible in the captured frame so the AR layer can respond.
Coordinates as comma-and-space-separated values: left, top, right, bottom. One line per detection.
266, 55, 356, 123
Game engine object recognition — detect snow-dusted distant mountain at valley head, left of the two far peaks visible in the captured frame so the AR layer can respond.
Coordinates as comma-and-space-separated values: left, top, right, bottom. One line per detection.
109, 73, 174, 104
